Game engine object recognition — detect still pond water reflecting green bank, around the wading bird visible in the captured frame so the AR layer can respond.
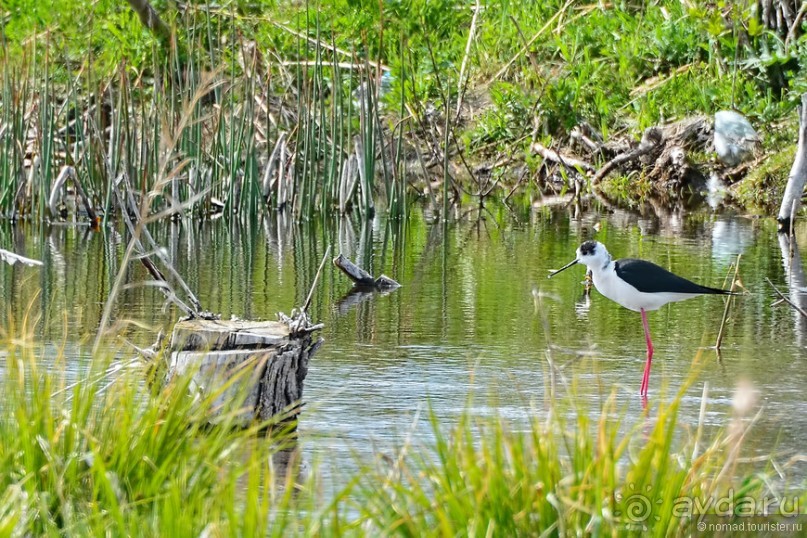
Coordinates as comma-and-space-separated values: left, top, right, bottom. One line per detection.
0, 203, 807, 484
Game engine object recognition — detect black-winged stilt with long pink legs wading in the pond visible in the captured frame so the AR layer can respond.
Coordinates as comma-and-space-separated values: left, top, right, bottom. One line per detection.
549, 241, 732, 396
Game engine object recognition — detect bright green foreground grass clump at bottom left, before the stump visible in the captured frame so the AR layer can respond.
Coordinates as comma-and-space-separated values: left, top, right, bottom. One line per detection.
0, 324, 326, 536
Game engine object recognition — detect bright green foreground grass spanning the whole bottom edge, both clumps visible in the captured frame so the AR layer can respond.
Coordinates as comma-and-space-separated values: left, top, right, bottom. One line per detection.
0, 328, 807, 536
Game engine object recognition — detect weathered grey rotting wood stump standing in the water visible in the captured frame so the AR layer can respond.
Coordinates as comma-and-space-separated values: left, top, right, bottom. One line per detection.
167, 319, 322, 427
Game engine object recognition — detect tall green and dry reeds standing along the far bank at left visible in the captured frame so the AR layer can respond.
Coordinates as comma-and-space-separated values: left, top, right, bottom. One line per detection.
0, 10, 406, 224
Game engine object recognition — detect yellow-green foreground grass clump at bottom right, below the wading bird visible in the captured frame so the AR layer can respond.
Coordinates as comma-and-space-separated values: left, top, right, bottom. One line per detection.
350, 360, 805, 536
